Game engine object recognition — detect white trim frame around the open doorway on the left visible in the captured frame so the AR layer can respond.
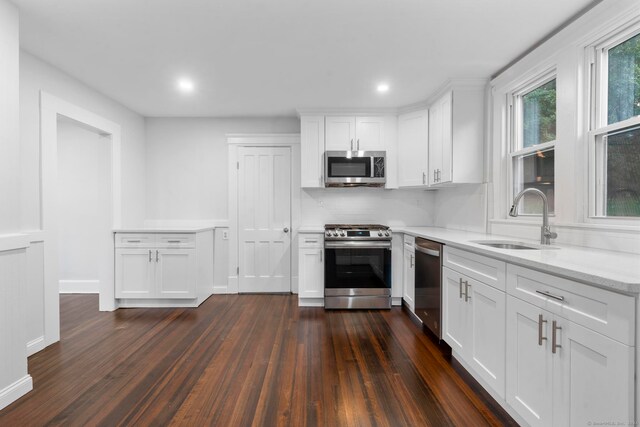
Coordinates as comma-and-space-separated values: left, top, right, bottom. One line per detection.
40, 91, 122, 346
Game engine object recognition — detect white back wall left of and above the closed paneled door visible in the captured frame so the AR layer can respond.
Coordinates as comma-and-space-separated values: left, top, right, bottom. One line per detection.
146, 118, 300, 220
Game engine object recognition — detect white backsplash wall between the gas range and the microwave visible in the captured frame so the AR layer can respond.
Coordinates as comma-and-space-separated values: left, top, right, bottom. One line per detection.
300, 188, 435, 227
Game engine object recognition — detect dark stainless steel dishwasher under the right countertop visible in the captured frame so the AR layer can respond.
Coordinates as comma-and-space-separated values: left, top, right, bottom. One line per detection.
415, 238, 442, 339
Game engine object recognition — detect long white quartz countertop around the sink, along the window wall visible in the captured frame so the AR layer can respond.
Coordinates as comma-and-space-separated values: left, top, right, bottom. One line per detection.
393, 227, 640, 294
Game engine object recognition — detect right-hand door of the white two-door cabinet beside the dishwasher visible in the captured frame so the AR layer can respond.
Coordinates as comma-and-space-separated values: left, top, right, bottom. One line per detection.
463, 277, 507, 398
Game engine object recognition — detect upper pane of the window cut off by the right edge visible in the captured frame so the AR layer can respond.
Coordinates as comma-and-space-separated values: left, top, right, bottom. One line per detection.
607, 34, 640, 124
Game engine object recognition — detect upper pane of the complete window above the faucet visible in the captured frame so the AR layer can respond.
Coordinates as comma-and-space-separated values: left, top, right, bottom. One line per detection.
522, 79, 556, 148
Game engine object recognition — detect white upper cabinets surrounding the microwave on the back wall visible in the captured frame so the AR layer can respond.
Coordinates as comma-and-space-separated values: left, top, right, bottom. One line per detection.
300, 114, 397, 188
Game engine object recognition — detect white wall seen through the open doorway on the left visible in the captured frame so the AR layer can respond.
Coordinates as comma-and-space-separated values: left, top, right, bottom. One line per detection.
58, 118, 112, 293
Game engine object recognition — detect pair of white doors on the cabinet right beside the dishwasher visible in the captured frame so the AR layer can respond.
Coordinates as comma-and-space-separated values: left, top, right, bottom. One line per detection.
442, 267, 506, 397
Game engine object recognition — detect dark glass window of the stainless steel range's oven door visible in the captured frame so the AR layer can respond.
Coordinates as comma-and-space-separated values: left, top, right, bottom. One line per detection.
325, 248, 391, 289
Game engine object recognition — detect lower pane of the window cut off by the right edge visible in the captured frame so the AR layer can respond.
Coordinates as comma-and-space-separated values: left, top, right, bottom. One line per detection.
605, 127, 640, 216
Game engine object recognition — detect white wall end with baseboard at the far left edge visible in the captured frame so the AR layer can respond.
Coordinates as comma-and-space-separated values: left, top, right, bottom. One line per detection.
0, 0, 32, 409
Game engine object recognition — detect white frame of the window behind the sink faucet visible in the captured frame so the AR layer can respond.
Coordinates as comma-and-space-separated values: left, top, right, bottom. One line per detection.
506, 70, 558, 220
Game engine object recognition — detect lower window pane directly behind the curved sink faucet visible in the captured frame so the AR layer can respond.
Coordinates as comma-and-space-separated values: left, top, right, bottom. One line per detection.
513, 149, 555, 215
